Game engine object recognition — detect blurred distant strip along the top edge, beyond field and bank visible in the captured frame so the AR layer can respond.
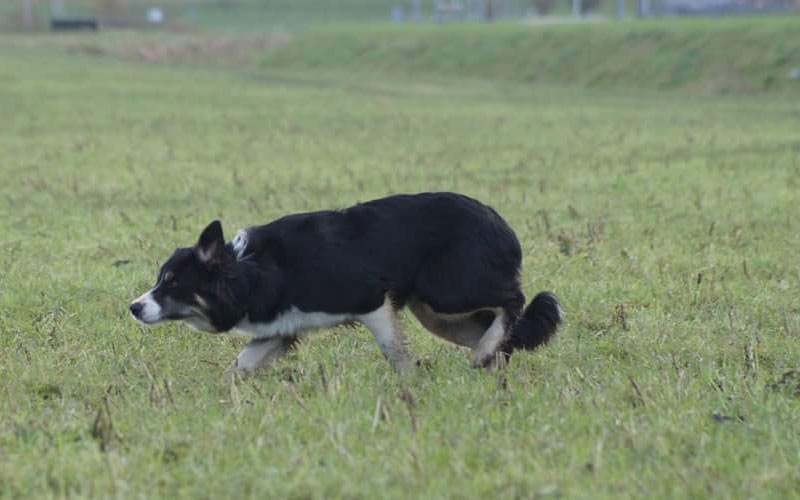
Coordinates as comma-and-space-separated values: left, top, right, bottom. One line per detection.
6, 0, 800, 31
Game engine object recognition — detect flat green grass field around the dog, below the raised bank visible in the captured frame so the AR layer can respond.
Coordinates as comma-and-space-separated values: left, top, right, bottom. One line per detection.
0, 17, 800, 498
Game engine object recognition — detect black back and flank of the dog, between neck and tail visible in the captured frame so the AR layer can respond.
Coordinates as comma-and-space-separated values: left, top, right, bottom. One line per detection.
240, 193, 522, 312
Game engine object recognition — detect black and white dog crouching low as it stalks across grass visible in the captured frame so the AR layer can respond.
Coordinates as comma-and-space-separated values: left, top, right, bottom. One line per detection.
130, 193, 562, 373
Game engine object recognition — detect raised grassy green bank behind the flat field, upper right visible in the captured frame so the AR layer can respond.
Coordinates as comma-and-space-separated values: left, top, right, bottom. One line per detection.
264, 17, 800, 94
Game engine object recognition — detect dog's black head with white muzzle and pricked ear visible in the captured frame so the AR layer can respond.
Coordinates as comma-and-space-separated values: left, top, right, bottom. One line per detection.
130, 221, 246, 333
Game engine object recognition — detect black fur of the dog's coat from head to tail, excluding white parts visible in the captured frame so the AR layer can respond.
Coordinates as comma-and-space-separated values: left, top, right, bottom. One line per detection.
132, 193, 561, 360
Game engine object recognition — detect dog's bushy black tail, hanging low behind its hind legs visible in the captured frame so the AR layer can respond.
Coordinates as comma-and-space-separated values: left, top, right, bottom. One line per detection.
503, 292, 564, 355
